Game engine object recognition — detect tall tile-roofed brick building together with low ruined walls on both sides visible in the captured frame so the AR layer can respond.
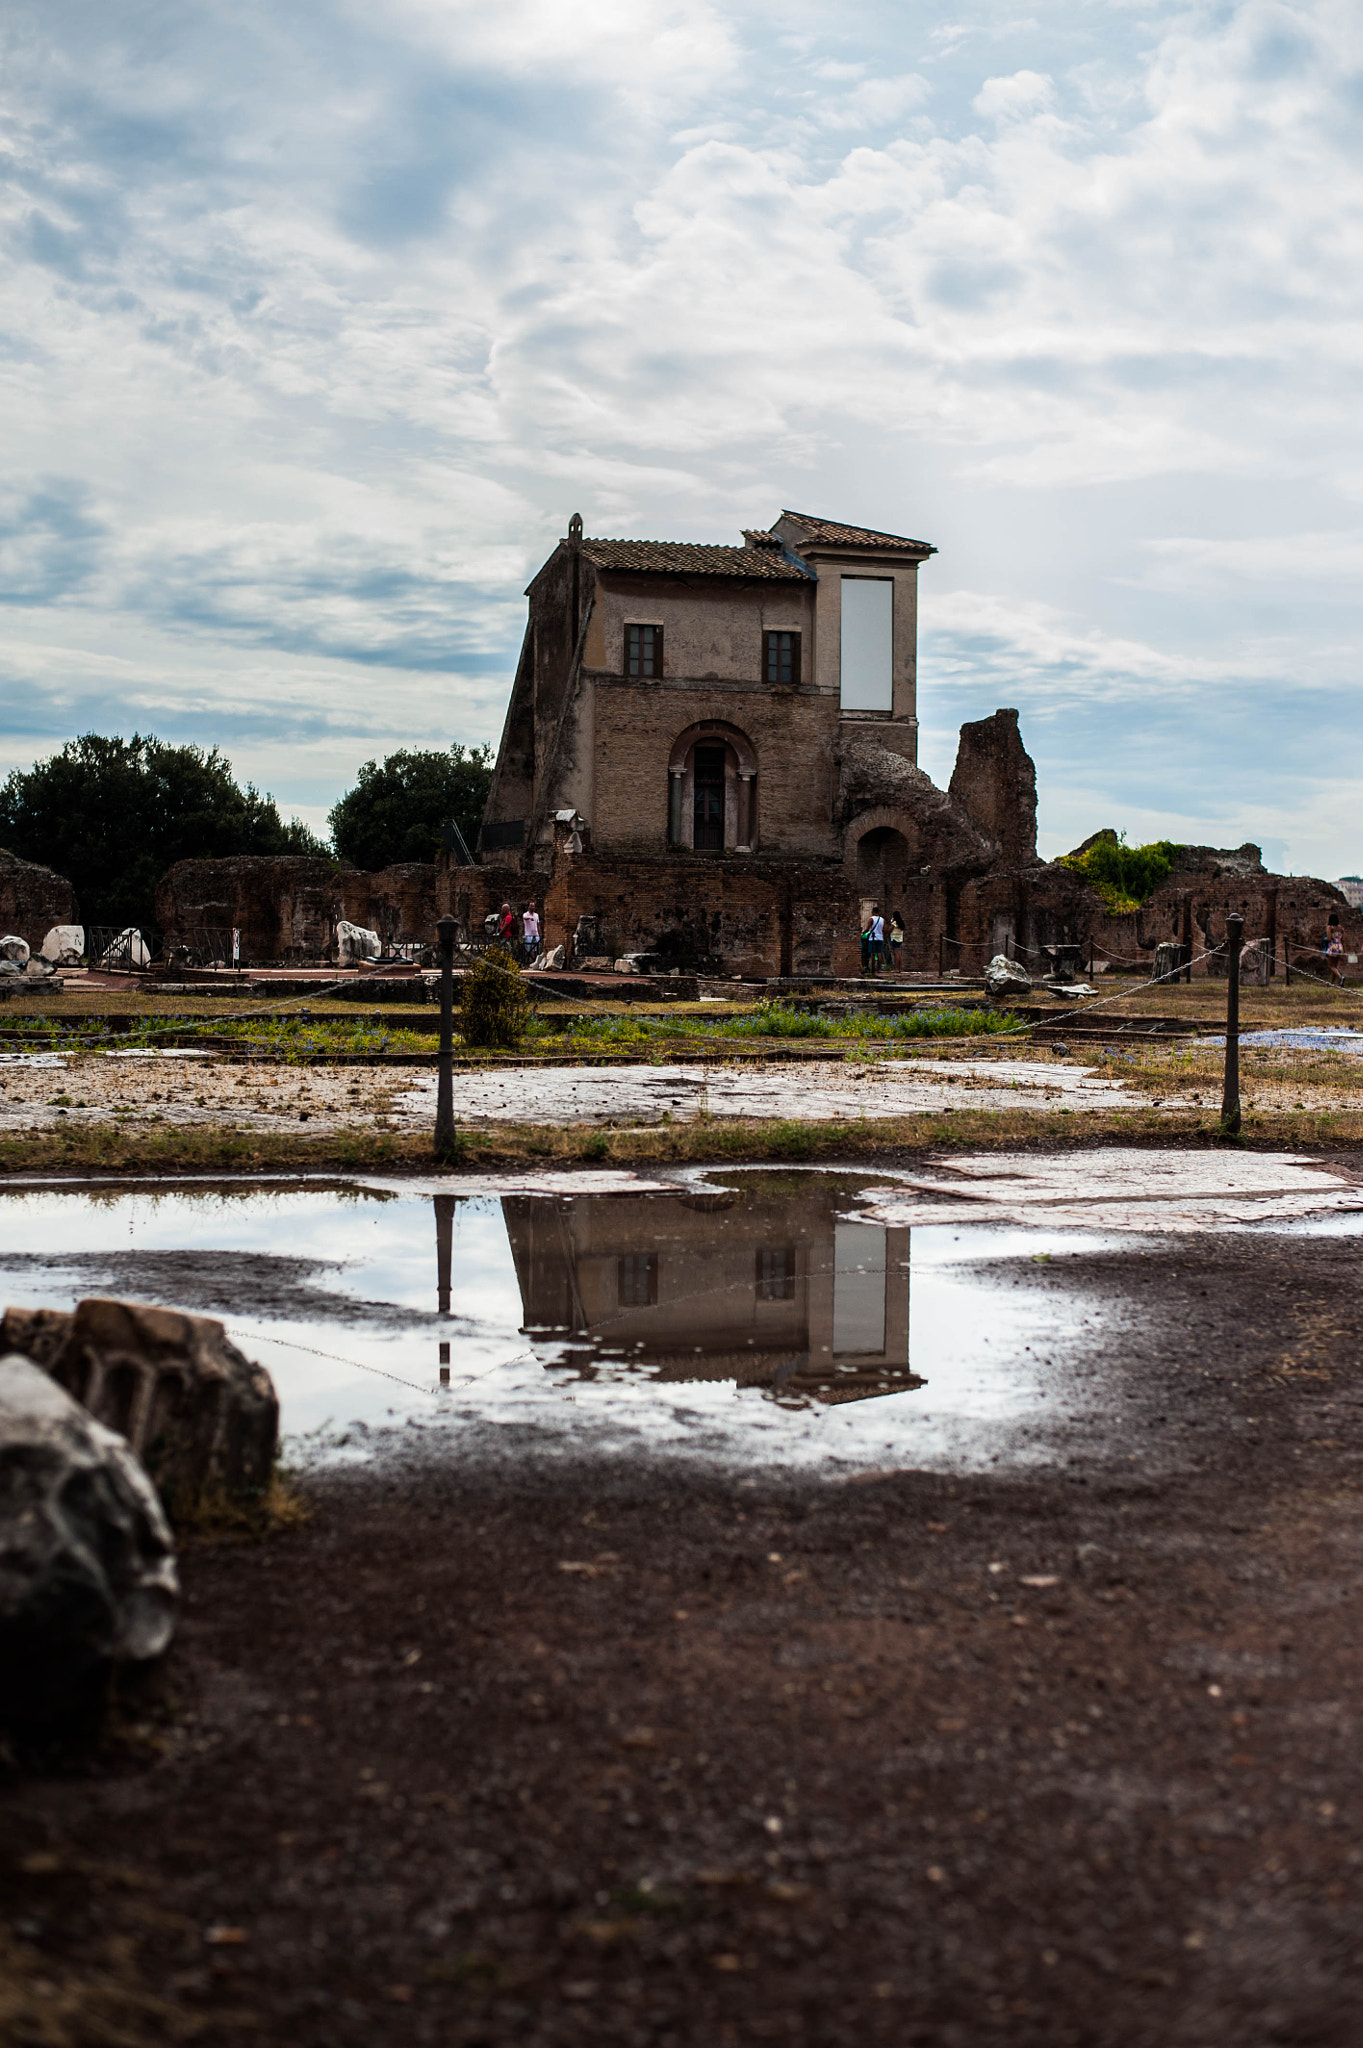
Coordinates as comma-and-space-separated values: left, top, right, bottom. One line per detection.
93, 512, 1363, 977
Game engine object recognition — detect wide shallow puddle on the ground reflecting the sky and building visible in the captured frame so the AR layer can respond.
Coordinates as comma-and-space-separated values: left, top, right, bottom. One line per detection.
0, 1149, 1363, 1468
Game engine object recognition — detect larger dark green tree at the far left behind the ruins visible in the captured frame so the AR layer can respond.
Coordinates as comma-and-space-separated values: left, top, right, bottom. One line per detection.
0, 733, 327, 926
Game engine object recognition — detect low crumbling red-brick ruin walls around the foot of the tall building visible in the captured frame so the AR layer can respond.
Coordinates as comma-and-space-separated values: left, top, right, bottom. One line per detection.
143, 711, 1363, 977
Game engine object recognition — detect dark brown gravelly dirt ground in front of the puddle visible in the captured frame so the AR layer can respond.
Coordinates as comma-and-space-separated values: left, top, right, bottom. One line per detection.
0, 1204, 1363, 2048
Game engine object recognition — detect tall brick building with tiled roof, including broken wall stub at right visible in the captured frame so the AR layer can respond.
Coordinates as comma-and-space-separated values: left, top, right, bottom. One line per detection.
452, 512, 1036, 975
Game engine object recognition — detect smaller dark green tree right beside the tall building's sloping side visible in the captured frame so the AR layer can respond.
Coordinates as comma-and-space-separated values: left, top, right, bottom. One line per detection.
327, 745, 491, 868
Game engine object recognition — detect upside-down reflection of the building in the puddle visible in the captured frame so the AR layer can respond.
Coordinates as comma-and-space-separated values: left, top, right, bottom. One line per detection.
501, 1180, 923, 1403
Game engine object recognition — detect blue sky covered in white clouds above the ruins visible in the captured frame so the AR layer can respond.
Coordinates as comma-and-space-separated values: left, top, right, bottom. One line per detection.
0, 0, 1363, 877
